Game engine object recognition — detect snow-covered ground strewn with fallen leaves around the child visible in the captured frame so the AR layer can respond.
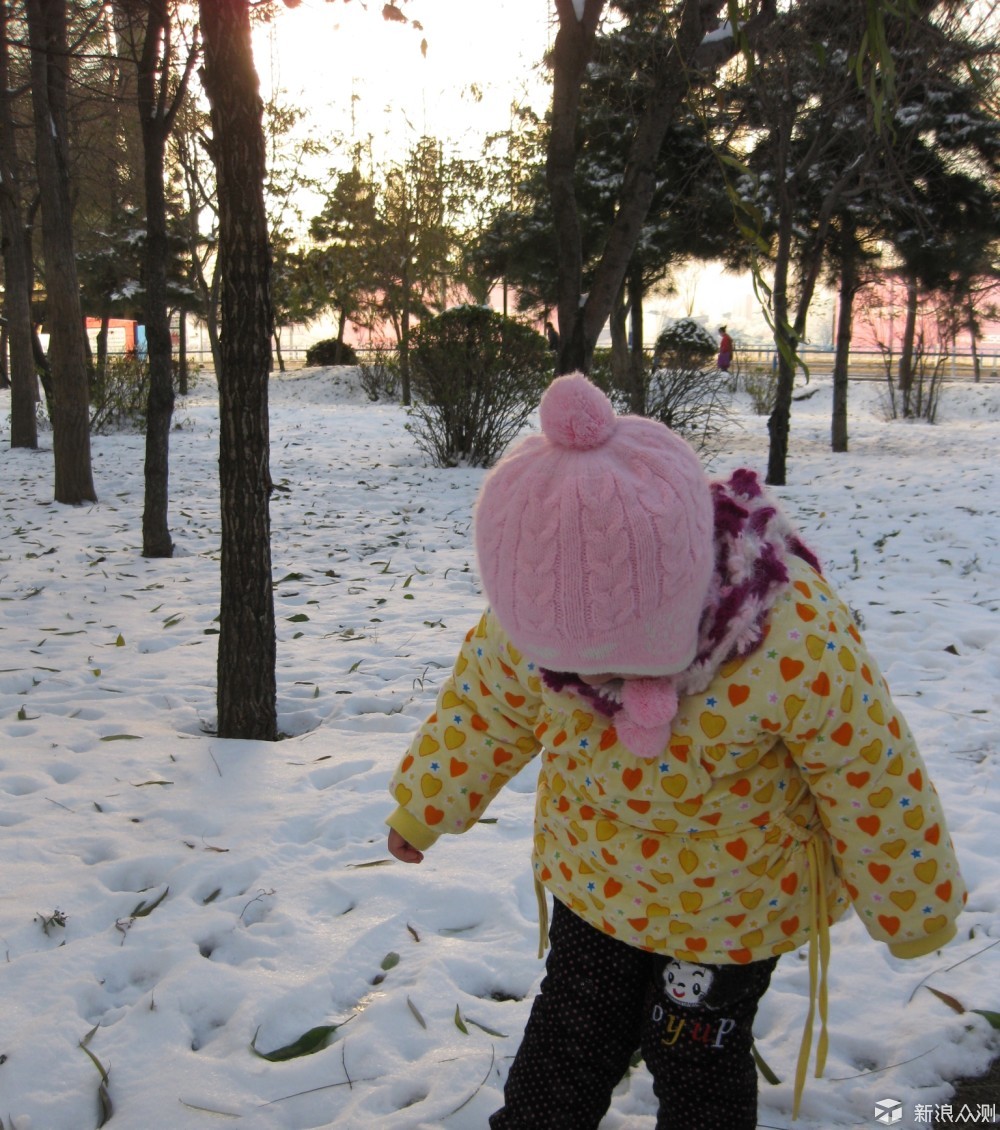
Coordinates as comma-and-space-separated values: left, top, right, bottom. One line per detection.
0, 370, 1000, 1130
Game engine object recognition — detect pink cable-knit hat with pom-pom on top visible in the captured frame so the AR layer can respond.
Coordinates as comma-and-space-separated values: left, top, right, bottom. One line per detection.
476, 373, 714, 676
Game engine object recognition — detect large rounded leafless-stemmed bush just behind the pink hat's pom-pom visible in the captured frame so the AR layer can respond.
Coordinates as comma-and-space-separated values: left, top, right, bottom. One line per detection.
409, 306, 553, 467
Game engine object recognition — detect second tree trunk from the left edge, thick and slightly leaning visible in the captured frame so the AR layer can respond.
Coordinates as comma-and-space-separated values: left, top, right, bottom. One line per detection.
25, 0, 97, 505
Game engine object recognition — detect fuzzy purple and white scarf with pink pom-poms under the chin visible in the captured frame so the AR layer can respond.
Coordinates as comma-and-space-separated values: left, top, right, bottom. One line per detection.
541, 468, 820, 757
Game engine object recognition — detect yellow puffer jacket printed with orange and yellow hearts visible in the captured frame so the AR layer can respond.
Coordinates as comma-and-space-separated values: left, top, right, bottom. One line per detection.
386, 558, 965, 963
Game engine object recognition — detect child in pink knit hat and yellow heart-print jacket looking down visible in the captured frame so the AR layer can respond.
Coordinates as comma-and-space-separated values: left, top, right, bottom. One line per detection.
386, 374, 965, 1130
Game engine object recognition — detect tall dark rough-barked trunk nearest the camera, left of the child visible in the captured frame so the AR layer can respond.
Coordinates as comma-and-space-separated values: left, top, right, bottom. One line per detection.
200, 0, 277, 741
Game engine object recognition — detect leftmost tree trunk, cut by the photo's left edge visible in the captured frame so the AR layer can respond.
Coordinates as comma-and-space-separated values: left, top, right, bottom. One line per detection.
0, 0, 38, 449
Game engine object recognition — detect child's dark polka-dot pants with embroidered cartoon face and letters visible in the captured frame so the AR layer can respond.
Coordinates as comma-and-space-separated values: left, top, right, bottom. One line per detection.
489, 902, 776, 1130
